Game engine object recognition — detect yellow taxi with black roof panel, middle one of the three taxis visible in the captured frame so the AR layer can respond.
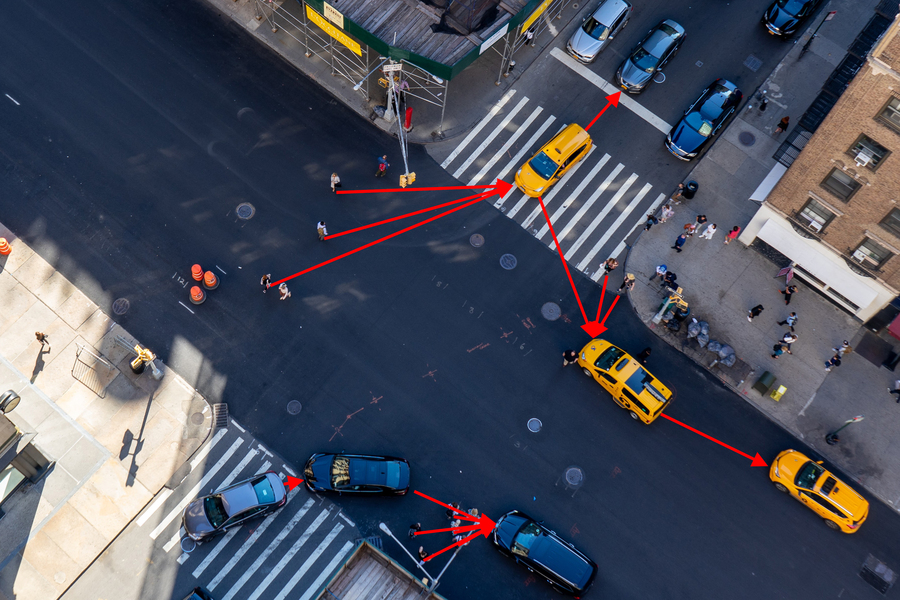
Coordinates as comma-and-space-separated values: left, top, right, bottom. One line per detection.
578, 338, 672, 423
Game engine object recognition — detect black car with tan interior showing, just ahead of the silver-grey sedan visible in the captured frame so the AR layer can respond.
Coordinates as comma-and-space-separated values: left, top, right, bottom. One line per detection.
303, 454, 409, 496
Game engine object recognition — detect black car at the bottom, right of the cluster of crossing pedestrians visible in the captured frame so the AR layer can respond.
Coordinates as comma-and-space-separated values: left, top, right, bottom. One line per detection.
494, 510, 597, 598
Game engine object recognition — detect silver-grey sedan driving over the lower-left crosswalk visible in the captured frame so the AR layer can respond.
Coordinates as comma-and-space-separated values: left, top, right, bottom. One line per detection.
181, 471, 287, 542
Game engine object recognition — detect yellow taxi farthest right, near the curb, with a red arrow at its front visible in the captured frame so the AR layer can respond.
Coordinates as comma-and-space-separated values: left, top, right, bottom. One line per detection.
769, 450, 869, 533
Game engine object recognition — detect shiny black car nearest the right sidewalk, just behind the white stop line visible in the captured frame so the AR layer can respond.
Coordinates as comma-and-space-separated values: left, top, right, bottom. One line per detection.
666, 79, 744, 160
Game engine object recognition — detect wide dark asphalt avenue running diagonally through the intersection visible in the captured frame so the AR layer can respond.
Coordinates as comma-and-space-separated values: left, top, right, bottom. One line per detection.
0, 0, 900, 600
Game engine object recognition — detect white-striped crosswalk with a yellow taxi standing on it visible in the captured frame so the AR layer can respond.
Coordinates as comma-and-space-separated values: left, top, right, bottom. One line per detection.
441, 89, 666, 281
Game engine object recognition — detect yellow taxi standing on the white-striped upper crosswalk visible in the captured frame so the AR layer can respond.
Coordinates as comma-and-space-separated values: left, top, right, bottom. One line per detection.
516, 123, 591, 198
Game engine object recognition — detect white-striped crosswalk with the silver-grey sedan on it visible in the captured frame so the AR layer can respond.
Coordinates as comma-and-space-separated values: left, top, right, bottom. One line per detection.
136, 421, 359, 600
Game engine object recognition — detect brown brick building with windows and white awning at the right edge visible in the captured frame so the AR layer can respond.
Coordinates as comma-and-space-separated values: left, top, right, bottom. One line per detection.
740, 11, 900, 320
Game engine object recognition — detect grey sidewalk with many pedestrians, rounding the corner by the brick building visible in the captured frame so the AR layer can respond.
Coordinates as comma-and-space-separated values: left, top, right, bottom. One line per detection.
625, 0, 900, 509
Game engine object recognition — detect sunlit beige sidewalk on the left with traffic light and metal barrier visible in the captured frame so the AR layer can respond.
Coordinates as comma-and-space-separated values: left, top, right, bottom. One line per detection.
0, 225, 212, 600
